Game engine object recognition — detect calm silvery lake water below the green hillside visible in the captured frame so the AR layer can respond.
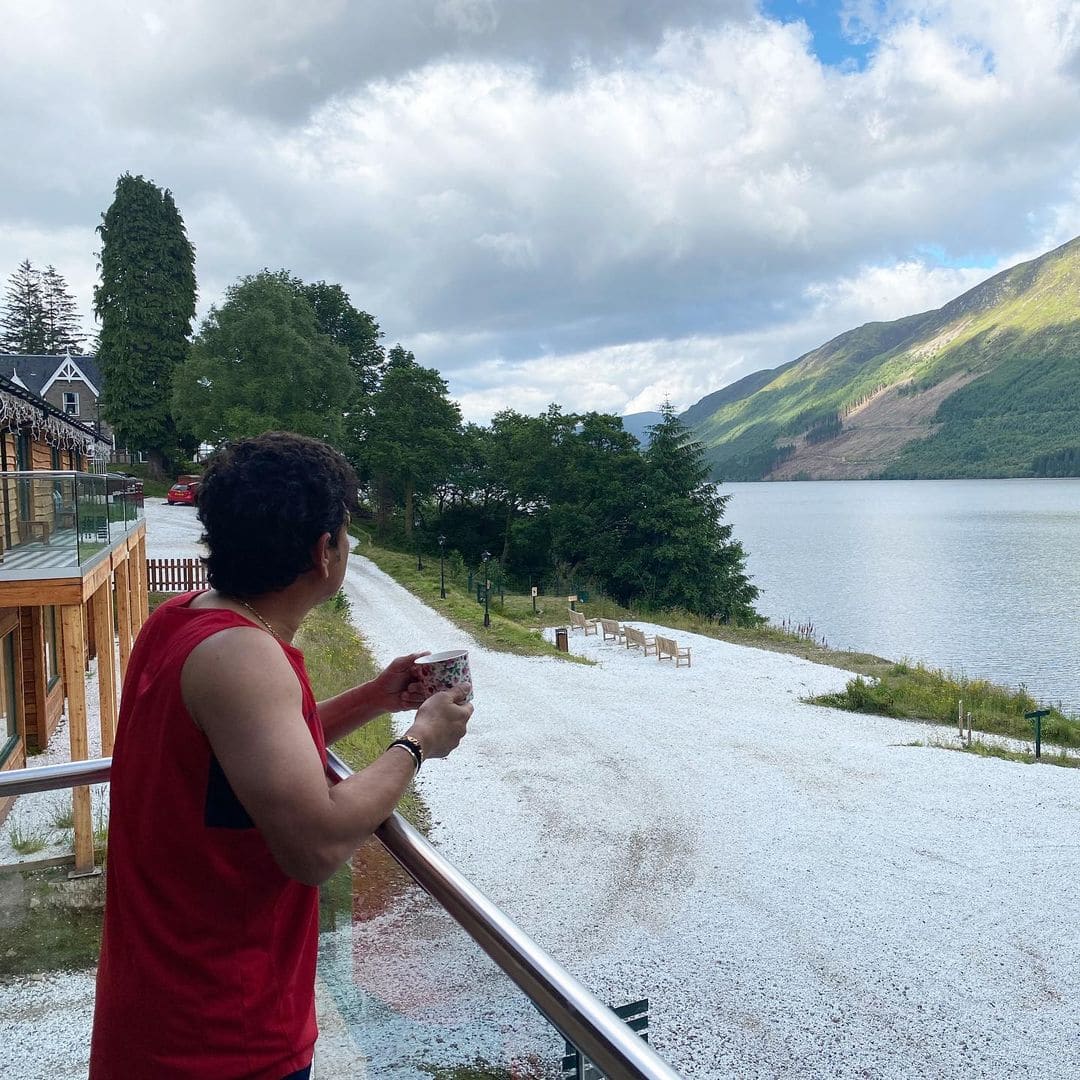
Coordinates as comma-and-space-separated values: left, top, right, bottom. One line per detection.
721, 478, 1080, 712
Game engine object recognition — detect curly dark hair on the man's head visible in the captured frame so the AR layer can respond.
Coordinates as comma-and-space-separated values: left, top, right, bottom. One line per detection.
199, 431, 356, 596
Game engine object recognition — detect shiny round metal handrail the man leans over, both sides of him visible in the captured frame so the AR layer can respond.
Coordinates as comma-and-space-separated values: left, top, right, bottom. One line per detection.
0, 751, 681, 1080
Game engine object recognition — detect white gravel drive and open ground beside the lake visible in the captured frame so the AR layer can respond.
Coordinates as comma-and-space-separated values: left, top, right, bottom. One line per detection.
0, 505, 1080, 1080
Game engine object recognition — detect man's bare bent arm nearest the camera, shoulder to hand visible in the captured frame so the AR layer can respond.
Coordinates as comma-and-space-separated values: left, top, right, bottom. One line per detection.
180, 627, 472, 885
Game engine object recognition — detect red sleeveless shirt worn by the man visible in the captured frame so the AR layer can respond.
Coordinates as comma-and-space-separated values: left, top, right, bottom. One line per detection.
90, 593, 326, 1080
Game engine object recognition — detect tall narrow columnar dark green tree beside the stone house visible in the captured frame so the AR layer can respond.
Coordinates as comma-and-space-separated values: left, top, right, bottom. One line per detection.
94, 173, 195, 473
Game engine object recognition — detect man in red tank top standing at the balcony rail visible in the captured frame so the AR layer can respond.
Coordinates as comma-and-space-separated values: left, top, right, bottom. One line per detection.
90, 433, 472, 1080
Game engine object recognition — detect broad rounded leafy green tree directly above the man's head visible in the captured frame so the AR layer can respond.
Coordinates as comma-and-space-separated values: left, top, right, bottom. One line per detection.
173, 270, 353, 444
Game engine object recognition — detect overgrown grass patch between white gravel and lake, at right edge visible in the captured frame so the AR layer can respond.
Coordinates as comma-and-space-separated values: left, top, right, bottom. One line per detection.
808, 663, 1080, 760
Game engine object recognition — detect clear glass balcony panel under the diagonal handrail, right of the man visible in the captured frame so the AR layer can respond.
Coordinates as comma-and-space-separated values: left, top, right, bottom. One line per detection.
316, 840, 604, 1080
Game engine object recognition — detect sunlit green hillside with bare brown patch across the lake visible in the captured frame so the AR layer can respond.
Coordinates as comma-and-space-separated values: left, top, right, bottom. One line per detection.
685, 239, 1080, 480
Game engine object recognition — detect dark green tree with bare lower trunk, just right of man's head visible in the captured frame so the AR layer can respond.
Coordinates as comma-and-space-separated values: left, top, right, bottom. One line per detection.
360, 345, 462, 537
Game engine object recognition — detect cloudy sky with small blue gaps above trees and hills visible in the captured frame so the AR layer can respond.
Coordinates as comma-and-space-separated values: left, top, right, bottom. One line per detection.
0, 0, 1080, 423
